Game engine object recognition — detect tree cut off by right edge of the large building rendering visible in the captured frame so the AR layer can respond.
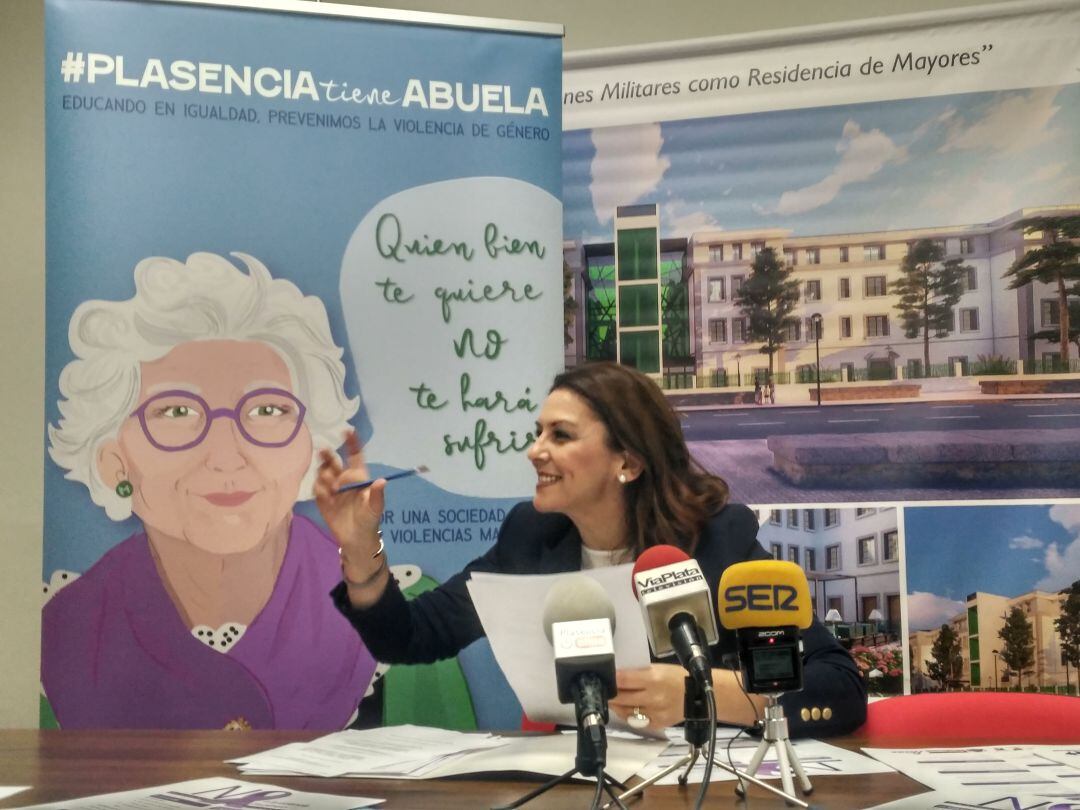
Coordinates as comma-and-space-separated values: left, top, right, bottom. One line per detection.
1003, 216, 1080, 369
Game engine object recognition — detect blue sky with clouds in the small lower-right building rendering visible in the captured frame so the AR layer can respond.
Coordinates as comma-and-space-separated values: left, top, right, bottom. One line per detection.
904, 504, 1080, 630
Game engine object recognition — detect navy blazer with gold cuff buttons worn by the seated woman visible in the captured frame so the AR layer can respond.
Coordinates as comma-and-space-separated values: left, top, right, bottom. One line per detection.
330, 501, 866, 737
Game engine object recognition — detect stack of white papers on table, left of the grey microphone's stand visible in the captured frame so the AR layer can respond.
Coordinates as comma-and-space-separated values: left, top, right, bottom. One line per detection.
229, 726, 504, 779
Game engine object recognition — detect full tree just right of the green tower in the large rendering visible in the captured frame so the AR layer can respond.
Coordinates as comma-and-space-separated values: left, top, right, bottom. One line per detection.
735, 247, 799, 380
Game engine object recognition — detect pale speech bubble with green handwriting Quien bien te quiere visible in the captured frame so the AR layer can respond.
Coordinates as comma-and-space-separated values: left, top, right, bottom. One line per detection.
340, 177, 563, 498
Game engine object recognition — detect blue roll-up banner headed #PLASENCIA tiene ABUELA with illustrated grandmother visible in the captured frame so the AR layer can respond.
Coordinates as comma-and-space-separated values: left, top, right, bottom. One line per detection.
42, 0, 563, 729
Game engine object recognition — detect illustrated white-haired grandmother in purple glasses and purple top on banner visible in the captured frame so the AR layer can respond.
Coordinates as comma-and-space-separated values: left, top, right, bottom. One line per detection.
41, 254, 375, 729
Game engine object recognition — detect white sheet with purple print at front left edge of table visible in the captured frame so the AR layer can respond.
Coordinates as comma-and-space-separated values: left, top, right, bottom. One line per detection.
12, 777, 386, 810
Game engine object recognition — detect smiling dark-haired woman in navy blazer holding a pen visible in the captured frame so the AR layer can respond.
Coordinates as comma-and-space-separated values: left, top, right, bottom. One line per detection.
315, 363, 866, 737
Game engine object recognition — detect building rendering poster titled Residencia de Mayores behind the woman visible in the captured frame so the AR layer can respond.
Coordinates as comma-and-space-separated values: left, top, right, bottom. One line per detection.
563, 2, 1080, 693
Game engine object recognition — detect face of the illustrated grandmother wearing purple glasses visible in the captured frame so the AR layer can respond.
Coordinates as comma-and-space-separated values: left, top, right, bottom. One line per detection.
98, 340, 312, 554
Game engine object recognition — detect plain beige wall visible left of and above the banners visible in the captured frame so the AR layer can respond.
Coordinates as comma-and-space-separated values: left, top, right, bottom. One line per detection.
0, 0, 993, 728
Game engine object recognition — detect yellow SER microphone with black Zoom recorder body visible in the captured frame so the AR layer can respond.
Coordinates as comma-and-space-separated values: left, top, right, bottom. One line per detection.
718, 559, 813, 694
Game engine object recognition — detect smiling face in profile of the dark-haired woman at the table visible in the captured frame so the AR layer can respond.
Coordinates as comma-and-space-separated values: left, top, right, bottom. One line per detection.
528, 389, 633, 523
